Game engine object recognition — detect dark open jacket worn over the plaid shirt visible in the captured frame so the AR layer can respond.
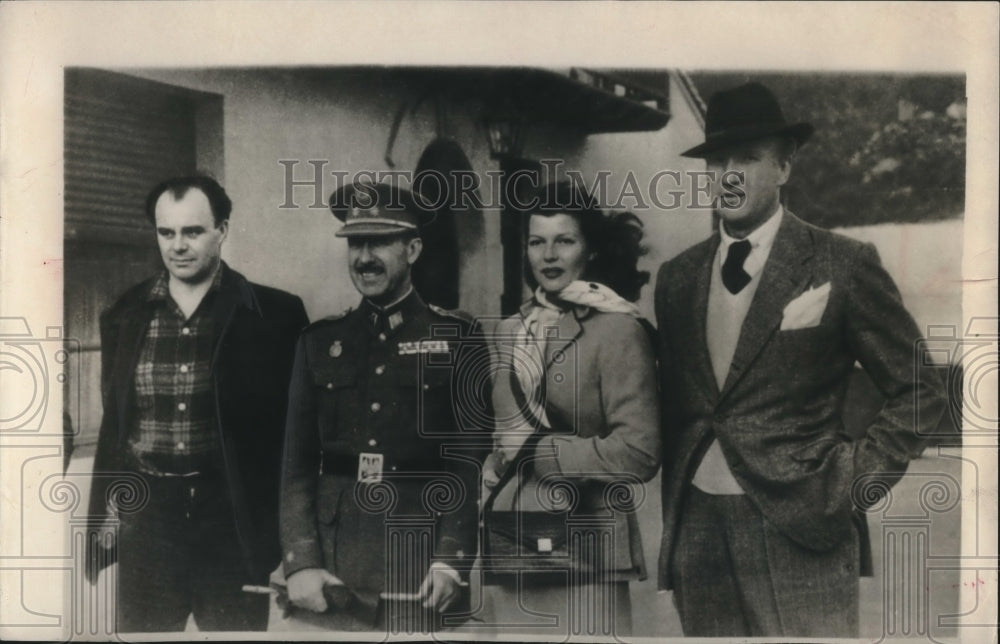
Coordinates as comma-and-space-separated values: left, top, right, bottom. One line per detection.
87, 262, 309, 582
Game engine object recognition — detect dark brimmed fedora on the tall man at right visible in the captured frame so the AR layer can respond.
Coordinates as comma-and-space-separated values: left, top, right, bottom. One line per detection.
681, 83, 815, 158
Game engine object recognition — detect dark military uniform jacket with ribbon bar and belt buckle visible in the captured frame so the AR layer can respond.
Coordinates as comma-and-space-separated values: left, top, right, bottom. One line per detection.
281, 292, 492, 597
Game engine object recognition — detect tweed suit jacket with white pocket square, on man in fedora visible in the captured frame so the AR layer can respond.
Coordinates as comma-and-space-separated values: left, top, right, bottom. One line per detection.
656, 211, 944, 588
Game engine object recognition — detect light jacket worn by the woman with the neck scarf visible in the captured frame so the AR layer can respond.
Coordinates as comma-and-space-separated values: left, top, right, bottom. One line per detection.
493, 305, 661, 581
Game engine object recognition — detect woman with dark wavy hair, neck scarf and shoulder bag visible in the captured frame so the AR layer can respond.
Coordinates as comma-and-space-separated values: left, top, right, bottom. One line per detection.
483, 182, 661, 636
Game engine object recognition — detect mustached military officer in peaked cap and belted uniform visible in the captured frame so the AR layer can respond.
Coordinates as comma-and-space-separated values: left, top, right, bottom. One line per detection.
281, 184, 492, 629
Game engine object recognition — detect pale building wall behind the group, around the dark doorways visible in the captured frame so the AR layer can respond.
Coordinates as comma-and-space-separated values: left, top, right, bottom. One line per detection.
118, 68, 711, 320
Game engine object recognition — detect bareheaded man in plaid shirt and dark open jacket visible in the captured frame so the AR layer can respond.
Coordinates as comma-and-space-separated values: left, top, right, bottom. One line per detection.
87, 176, 308, 632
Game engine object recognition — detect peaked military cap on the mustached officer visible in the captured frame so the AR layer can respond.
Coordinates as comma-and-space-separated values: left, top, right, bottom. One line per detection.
330, 182, 434, 237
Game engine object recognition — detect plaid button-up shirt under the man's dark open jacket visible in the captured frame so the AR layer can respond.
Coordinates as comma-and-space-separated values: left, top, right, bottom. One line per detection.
129, 270, 222, 474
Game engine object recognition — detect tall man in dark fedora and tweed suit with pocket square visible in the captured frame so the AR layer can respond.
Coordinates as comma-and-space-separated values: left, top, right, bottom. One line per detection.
656, 84, 944, 637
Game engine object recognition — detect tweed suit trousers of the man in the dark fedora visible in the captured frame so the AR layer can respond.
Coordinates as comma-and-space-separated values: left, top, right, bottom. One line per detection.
672, 486, 859, 638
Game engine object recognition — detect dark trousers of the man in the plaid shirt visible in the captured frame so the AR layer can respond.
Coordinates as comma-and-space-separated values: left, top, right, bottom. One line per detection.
118, 475, 269, 632
